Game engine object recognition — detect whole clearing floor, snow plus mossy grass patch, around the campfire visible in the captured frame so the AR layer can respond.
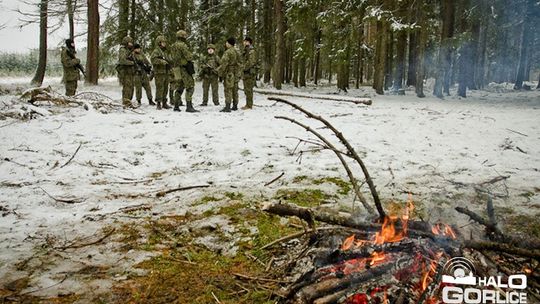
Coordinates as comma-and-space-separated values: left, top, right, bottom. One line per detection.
0, 79, 540, 303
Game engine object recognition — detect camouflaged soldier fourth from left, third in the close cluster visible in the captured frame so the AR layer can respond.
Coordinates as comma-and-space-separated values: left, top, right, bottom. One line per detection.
151, 36, 172, 110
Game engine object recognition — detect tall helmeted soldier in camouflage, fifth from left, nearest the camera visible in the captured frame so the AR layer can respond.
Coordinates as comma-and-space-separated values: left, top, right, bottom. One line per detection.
171, 30, 199, 113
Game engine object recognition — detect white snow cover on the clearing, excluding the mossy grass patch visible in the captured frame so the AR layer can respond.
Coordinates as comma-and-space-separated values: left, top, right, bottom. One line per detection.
0, 79, 540, 300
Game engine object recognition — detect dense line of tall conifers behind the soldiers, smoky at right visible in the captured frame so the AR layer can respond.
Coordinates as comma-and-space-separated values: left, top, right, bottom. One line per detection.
11, 0, 540, 94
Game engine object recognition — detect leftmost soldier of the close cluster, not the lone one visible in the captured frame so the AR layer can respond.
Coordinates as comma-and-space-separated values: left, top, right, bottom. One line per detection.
117, 36, 135, 108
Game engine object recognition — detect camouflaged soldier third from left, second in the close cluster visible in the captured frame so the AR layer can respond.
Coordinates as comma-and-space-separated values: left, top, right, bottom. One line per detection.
133, 43, 156, 106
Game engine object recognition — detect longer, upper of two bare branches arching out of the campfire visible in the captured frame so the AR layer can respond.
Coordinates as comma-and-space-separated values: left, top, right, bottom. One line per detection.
274, 97, 386, 222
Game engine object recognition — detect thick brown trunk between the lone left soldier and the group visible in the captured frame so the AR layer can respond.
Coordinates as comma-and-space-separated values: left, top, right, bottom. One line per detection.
86, 0, 99, 85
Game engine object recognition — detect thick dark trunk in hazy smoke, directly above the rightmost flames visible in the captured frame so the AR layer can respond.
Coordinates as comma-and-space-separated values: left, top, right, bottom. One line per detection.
433, 0, 455, 98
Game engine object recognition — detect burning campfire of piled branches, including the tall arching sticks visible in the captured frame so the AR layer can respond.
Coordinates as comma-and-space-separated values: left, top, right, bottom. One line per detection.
263, 98, 540, 304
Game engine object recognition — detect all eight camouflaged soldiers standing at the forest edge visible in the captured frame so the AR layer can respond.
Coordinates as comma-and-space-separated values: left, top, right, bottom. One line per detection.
61, 30, 258, 113
